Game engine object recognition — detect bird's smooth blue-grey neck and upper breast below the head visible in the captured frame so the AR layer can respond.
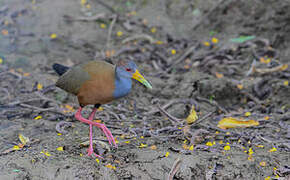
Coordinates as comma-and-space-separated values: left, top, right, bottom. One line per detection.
114, 76, 132, 98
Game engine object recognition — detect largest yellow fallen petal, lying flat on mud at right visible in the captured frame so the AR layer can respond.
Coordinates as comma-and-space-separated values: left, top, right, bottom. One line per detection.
218, 117, 259, 129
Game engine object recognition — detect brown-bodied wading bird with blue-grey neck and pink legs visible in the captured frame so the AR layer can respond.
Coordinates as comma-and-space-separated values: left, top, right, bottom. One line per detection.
53, 60, 152, 157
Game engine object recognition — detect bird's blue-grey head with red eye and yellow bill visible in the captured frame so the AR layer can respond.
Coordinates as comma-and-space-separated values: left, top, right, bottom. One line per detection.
116, 60, 152, 89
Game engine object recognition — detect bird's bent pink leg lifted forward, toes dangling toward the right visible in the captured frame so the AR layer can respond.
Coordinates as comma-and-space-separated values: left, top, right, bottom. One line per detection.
75, 107, 117, 147
